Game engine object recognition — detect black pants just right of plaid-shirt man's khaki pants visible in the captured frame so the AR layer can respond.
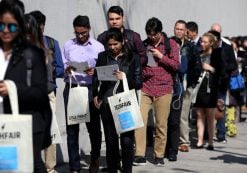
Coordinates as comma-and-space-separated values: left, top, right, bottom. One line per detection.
166, 96, 183, 157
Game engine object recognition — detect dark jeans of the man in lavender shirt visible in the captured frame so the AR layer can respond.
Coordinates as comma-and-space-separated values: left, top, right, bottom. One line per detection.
63, 86, 102, 171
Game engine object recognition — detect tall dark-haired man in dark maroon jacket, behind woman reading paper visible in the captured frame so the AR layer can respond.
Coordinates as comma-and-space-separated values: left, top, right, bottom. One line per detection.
97, 6, 147, 65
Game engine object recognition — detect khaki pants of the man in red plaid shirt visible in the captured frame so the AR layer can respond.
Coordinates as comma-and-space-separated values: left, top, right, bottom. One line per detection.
135, 92, 172, 158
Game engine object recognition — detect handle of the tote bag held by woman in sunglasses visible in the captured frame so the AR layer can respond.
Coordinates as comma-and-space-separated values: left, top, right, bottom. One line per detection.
4, 80, 19, 116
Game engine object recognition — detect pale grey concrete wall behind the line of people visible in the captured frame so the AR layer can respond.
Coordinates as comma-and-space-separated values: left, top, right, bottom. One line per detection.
19, 0, 247, 162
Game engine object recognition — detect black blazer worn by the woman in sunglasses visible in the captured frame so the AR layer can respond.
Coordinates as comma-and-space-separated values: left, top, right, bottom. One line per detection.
3, 45, 51, 136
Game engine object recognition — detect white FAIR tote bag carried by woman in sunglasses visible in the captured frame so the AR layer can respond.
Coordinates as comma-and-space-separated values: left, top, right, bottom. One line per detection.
0, 81, 33, 173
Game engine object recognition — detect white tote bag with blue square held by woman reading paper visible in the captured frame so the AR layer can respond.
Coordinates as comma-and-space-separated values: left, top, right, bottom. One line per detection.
108, 75, 144, 134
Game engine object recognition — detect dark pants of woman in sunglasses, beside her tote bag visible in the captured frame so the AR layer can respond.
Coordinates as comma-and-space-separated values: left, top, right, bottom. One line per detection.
33, 132, 47, 173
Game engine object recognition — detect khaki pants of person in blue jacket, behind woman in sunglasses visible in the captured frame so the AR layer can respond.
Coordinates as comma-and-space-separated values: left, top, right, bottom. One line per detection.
44, 92, 56, 173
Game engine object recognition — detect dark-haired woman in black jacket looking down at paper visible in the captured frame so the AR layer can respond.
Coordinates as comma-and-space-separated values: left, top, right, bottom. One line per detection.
93, 28, 142, 173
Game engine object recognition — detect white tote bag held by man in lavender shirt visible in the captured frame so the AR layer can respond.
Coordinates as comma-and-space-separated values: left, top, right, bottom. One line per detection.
67, 72, 90, 125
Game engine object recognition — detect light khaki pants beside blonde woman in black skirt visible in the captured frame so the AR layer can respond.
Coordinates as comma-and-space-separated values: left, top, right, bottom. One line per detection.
179, 88, 193, 145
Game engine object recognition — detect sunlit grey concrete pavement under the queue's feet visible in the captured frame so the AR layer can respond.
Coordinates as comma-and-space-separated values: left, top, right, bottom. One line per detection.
57, 115, 247, 173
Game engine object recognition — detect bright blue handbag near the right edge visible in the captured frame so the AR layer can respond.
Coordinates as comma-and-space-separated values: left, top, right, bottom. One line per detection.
229, 73, 245, 92
